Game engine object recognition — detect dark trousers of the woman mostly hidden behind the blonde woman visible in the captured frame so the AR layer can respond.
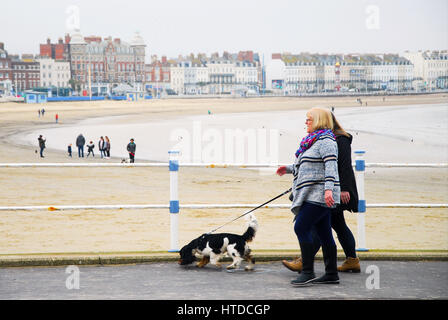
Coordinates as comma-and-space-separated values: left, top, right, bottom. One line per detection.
312, 208, 356, 258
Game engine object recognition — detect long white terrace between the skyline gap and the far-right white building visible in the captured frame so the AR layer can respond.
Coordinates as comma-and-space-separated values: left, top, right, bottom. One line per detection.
265, 53, 414, 94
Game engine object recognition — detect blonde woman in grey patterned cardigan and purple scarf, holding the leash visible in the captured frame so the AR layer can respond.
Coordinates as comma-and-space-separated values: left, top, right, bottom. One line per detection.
277, 108, 340, 286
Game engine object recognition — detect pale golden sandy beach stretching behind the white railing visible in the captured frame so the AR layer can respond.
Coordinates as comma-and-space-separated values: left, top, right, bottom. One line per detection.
0, 94, 448, 254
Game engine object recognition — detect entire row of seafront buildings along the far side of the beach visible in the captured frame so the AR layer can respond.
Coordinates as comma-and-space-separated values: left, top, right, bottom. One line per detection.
0, 30, 448, 97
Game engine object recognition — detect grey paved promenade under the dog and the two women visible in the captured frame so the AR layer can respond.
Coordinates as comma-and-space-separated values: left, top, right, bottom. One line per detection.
0, 260, 448, 300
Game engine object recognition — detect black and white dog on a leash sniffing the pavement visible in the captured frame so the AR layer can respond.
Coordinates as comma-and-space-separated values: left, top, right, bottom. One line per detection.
179, 214, 258, 270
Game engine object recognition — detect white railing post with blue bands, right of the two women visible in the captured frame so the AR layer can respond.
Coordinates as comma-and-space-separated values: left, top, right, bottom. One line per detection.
355, 150, 369, 251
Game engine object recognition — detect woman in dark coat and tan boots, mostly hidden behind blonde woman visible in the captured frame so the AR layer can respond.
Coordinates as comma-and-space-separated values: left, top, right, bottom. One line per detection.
282, 113, 361, 273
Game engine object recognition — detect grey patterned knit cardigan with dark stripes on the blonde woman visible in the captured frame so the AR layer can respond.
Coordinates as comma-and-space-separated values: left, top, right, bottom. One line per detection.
286, 135, 341, 214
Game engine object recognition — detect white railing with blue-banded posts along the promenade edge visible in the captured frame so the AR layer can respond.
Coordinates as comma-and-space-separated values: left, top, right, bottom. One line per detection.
0, 155, 448, 252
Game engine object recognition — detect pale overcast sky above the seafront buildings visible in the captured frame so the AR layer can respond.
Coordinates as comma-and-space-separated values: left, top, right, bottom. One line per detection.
0, 0, 448, 61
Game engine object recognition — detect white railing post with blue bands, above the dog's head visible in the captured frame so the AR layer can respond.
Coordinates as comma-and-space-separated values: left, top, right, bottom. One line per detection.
168, 151, 179, 252
